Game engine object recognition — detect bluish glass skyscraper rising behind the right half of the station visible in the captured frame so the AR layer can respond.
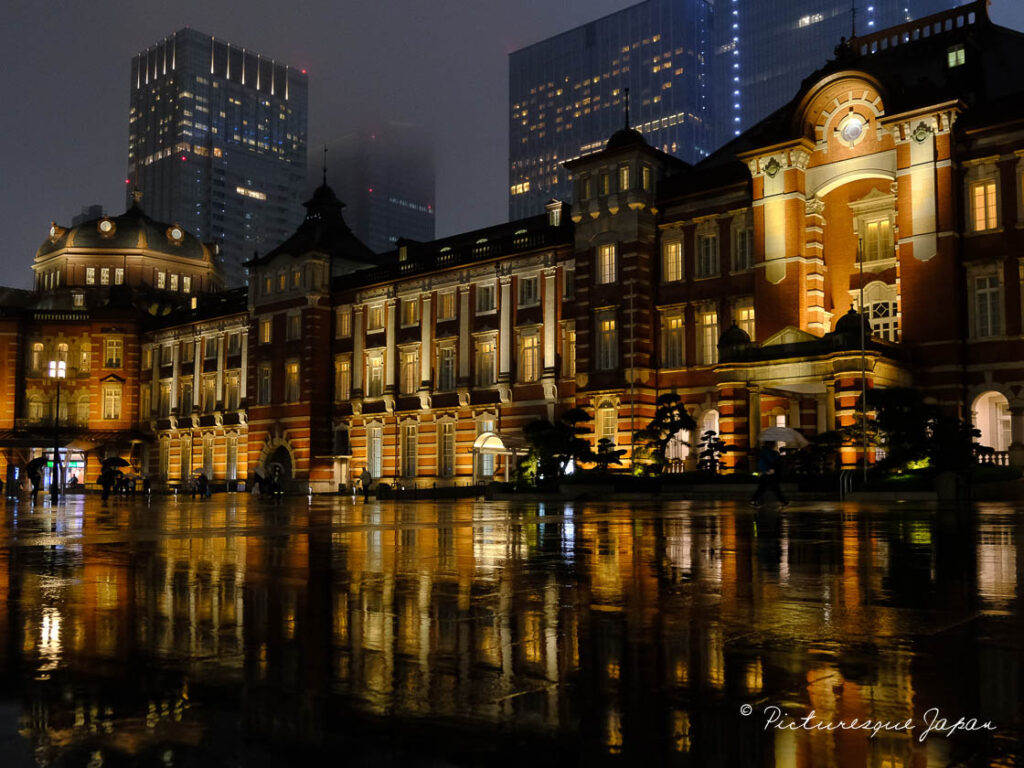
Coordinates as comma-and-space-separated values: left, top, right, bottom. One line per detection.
509, 0, 966, 218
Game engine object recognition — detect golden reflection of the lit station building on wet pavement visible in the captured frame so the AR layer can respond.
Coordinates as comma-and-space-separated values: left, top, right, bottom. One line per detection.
0, 503, 1024, 768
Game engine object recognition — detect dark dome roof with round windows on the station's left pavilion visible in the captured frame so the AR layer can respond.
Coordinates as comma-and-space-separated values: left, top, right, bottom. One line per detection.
36, 203, 206, 261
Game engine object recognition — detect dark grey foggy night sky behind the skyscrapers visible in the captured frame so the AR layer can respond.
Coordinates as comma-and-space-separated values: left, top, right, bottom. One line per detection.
6, 0, 1024, 287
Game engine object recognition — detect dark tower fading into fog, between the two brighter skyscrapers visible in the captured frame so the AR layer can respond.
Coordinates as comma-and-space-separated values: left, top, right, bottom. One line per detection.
327, 123, 435, 253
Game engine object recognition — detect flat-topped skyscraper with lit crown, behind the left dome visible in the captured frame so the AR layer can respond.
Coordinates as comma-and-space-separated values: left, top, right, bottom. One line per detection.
126, 29, 308, 286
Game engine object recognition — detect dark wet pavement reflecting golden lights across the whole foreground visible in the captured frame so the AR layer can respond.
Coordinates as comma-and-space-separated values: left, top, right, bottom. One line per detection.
0, 496, 1024, 768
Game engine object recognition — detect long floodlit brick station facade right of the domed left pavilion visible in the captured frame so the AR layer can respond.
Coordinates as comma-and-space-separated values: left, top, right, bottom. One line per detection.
2, 2, 1024, 492
